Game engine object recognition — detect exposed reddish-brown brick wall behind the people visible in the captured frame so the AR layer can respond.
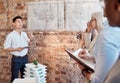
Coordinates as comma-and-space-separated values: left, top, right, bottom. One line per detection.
0, 0, 86, 83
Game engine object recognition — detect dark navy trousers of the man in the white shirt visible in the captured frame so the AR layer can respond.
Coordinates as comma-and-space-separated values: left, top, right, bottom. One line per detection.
11, 55, 28, 82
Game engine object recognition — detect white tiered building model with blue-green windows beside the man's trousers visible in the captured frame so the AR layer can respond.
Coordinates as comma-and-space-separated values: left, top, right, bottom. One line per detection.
24, 63, 47, 83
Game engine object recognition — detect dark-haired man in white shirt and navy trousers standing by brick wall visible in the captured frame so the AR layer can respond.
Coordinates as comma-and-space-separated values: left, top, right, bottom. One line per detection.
4, 16, 30, 82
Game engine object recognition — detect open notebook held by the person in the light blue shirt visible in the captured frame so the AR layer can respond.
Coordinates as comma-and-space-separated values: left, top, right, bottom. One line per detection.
65, 48, 95, 72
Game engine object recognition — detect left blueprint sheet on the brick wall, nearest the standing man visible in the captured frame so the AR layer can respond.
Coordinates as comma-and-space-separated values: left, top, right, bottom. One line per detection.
28, 1, 64, 30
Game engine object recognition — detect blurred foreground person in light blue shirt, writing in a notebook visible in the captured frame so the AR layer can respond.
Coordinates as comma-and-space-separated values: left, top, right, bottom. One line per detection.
80, 0, 120, 83
